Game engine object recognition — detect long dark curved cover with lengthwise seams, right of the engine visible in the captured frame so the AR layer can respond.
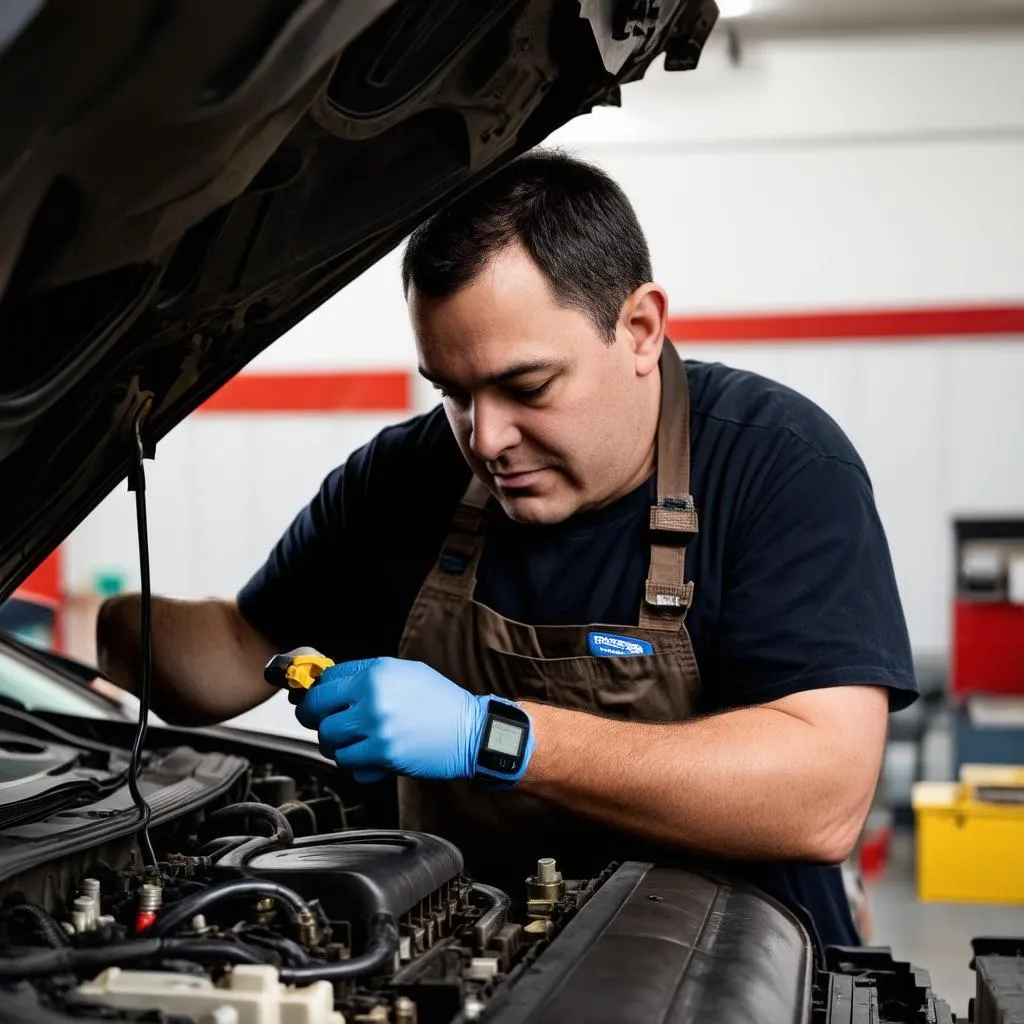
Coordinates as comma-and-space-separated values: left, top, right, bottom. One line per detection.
487, 861, 814, 1024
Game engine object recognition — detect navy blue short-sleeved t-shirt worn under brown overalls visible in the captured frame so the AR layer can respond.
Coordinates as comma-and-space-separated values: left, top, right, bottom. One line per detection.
239, 361, 916, 945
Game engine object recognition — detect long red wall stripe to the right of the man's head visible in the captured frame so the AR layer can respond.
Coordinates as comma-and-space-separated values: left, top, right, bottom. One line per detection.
669, 306, 1024, 342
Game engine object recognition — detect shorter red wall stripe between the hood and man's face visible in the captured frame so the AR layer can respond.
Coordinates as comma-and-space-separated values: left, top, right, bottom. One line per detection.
198, 370, 412, 413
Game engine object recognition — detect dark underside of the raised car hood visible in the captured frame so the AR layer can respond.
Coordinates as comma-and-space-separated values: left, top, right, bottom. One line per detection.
0, 0, 717, 599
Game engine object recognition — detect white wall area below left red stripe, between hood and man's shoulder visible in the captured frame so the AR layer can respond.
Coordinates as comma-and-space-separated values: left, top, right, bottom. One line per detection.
65, 414, 399, 597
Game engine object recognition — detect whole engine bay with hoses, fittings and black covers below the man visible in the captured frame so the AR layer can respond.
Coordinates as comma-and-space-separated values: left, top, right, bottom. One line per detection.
0, 748, 1024, 1024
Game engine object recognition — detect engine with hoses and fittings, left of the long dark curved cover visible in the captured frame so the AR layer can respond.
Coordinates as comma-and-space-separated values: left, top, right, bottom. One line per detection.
0, 771, 614, 1024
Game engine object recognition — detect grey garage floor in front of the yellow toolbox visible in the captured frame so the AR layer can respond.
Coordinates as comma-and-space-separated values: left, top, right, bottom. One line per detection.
867, 831, 1024, 1020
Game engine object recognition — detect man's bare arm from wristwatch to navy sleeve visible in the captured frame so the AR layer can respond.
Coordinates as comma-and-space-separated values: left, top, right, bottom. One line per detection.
517, 686, 889, 863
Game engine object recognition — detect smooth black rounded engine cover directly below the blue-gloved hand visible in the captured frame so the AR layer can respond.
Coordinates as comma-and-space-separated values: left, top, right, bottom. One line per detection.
246, 831, 463, 945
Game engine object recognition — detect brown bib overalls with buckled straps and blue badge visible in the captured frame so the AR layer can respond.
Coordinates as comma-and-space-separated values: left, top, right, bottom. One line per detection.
398, 341, 700, 886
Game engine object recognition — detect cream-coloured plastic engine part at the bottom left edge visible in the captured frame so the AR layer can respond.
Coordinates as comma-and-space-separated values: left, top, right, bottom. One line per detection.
73, 964, 345, 1024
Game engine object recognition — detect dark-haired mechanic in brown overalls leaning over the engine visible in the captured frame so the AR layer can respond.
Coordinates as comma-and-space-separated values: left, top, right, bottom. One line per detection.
97, 153, 915, 944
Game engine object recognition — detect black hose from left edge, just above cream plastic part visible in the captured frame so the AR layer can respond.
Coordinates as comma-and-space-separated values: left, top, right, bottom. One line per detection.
0, 938, 266, 978
